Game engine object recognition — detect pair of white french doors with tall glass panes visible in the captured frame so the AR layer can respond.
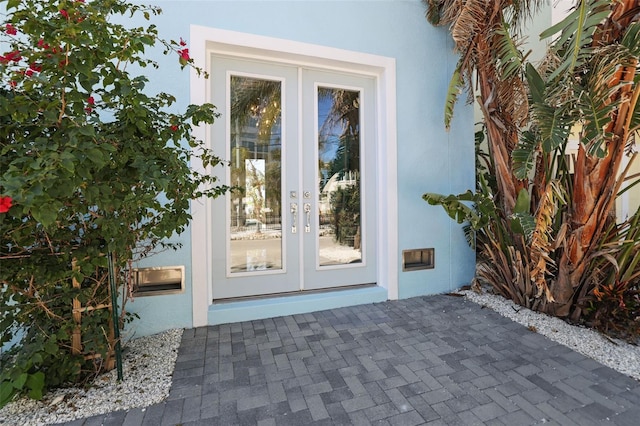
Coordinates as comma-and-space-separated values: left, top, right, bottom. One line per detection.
211, 56, 376, 300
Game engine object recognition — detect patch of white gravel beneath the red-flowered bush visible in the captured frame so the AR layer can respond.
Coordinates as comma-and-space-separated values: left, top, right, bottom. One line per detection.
0, 329, 183, 426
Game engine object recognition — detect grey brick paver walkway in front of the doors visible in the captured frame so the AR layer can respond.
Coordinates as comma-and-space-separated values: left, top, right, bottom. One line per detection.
60, 295, 640, 426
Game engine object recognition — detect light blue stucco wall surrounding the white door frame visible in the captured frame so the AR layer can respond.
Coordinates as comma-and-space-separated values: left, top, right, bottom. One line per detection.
127, 0, 475, 335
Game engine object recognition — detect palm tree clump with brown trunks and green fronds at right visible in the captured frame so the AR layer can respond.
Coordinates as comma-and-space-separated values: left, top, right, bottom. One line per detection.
425, 0, 640, 319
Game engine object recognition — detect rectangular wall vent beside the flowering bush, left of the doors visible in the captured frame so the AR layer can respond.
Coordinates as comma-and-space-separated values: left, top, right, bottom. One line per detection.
133, 266, 184, 296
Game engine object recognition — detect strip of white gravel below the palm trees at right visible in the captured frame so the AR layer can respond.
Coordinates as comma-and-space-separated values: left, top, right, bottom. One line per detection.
459, 290, 640, 380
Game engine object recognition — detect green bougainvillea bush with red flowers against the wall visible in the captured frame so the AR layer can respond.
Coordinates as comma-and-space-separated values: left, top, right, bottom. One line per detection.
0, 0, 226, 406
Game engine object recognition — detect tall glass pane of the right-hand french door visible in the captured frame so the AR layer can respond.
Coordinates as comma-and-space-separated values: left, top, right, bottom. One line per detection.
317, 86, 362, 266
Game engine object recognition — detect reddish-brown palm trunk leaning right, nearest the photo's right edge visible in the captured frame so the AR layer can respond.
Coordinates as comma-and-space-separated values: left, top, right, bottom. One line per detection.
543, 0, 640, 320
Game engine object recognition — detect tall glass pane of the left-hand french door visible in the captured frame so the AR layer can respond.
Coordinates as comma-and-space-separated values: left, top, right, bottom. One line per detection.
228, 75, 282, 273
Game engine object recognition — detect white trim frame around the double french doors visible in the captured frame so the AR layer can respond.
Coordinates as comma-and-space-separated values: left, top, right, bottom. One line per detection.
190, 25, 399, 327
